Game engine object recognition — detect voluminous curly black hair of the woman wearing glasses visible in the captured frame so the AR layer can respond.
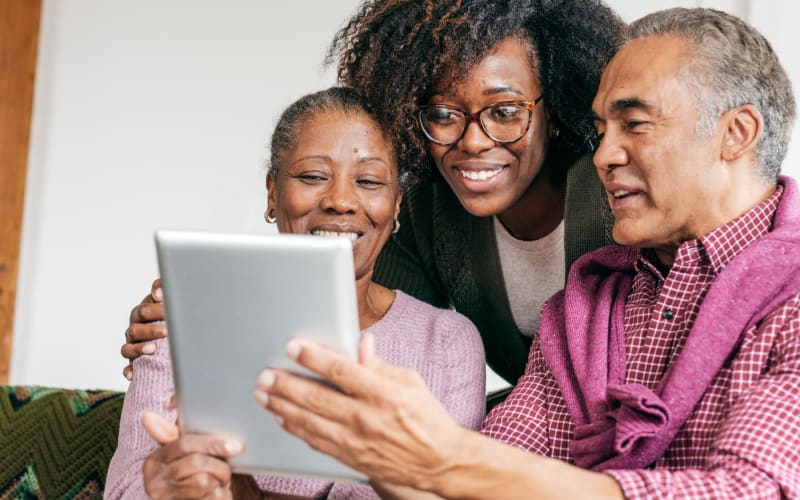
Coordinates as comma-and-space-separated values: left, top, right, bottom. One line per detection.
327, 0, 626, 180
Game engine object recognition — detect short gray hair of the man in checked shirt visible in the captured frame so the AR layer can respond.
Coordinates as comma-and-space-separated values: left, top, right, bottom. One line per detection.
630, 8, 795, 179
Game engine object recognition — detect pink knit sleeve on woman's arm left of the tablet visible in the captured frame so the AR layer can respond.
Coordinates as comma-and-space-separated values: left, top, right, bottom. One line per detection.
104, 339, 177, 499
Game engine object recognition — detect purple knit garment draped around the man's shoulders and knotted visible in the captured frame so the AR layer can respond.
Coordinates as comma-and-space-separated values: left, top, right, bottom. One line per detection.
539, 177, 800, 471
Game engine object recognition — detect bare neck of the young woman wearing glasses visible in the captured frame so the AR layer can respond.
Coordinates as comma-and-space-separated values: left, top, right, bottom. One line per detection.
497, 166, 567, 241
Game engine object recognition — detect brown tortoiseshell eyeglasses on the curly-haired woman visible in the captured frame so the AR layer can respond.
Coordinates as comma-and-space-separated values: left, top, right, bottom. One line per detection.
419, 96, 543, 146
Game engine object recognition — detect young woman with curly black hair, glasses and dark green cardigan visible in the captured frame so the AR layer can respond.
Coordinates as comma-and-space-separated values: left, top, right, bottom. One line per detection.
123, 0, 624, 392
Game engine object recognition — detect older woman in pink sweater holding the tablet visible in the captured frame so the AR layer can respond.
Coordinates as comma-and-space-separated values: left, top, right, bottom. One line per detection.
107, 88, 485, 498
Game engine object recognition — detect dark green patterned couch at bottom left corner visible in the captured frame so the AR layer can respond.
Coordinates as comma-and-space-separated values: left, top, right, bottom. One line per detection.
0, 386, 125, 499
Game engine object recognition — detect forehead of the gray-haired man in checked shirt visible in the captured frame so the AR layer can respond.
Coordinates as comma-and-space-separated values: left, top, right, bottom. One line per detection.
592, 35, 691, 116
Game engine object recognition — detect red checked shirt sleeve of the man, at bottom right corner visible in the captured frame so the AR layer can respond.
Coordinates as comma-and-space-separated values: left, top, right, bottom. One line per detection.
607, 295, 800, 499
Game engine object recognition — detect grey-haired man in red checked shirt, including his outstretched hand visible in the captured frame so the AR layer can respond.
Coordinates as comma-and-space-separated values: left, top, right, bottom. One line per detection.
153, 9, 800, 498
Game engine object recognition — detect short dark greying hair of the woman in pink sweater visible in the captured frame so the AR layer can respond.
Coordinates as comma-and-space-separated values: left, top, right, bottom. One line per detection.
267, 87, 407, 183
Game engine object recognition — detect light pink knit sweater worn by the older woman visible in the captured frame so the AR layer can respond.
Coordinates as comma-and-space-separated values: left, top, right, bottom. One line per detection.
105, 291, 486, 498
